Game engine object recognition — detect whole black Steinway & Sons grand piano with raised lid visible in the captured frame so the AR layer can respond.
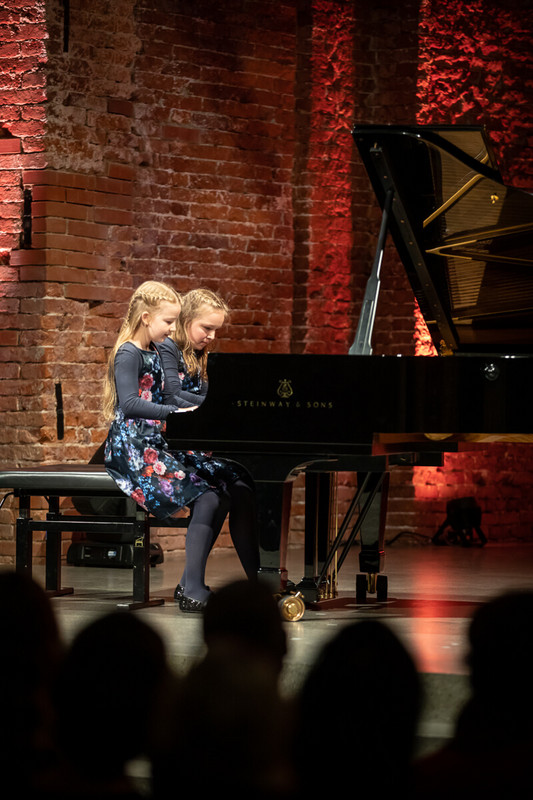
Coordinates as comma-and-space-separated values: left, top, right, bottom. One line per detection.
167, 126, 533, 618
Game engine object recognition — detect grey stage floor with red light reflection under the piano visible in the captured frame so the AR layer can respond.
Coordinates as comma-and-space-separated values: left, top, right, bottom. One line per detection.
21, 542, 533, 749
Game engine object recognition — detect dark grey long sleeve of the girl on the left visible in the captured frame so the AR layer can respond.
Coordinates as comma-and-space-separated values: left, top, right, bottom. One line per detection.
115, 342, 178, 419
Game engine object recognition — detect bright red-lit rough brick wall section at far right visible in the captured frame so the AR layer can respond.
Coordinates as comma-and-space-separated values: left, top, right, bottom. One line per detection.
406, 0, 533, 541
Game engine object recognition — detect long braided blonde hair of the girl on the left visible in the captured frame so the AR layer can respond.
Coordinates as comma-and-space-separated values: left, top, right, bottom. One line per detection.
102, 281, 181, 420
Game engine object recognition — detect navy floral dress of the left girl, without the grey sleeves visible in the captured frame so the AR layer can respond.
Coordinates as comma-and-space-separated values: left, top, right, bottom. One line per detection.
104, 345, 239, 519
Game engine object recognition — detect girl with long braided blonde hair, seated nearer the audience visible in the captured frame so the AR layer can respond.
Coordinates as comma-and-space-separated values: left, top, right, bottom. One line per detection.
103, 281, 258, 612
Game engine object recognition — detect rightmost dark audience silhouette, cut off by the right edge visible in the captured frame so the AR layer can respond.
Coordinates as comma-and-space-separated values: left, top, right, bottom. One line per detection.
414, 591, 533, 800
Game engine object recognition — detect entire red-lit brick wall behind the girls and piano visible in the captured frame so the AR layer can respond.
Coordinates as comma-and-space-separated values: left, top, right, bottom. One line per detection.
0, 0, 533, 562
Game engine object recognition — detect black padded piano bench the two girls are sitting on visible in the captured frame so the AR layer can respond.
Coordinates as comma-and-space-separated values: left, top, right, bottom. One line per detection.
0, 464, 188, 610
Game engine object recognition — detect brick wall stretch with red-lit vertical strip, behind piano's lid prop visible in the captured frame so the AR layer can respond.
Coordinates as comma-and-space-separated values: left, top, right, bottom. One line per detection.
286, 0, 424, 538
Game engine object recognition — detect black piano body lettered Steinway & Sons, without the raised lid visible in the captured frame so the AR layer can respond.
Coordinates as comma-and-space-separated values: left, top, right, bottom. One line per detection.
166, 353, 533, 599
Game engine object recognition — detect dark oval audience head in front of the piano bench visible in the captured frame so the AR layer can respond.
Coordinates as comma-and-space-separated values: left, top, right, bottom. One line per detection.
51, 611, 170, 785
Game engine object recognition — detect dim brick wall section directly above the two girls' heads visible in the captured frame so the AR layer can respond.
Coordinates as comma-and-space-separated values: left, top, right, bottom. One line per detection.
130, 2, 296, 352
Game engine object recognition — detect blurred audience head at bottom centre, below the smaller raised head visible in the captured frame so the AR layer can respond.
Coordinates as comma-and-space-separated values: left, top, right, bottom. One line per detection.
153, 644, 294, 800
